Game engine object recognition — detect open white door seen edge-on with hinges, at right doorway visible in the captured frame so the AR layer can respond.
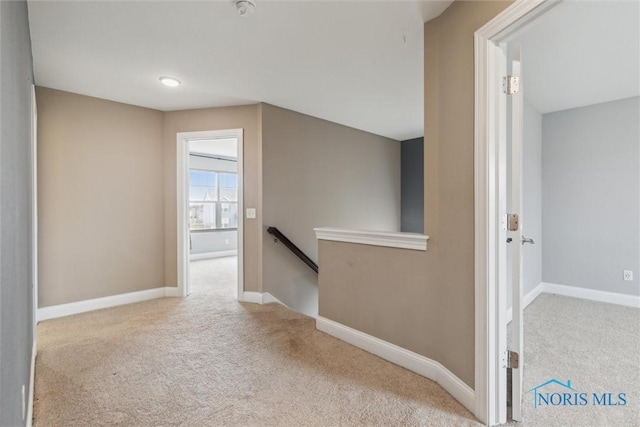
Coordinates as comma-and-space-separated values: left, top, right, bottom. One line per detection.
507, 49, 533, 421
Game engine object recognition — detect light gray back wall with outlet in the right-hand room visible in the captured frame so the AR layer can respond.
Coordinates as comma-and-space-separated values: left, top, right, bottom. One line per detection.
542, 97, 640, 295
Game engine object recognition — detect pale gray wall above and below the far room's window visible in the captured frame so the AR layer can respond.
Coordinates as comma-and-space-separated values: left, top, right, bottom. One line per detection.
189, 156, 238, 255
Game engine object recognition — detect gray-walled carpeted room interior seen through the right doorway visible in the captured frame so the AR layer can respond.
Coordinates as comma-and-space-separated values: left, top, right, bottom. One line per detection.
507, 2, 640, 425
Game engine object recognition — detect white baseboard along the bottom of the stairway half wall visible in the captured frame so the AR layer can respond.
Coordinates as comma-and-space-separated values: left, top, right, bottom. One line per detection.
316, 316, 476, 412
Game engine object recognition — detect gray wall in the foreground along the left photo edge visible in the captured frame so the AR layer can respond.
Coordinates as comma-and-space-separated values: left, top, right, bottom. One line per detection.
0, 1, 34, 426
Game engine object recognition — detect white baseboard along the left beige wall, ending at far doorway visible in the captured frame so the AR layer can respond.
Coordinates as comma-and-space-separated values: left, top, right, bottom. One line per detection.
38, 287, 181, 322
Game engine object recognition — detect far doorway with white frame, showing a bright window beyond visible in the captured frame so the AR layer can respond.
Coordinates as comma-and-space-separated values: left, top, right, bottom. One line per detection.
177, 129, 244, 300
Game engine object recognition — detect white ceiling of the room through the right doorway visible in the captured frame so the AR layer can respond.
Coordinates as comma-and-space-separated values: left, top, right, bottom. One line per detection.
510, 0, 640, 113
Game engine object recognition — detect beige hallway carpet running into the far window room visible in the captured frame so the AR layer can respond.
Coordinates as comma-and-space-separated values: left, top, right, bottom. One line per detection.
34, 258, 479, 427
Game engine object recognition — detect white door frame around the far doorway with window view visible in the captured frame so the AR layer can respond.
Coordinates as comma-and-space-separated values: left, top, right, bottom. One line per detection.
176, 129, 244, 301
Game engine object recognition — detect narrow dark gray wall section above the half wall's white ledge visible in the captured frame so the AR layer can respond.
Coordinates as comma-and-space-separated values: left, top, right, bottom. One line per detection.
400, 138, 424, 233
